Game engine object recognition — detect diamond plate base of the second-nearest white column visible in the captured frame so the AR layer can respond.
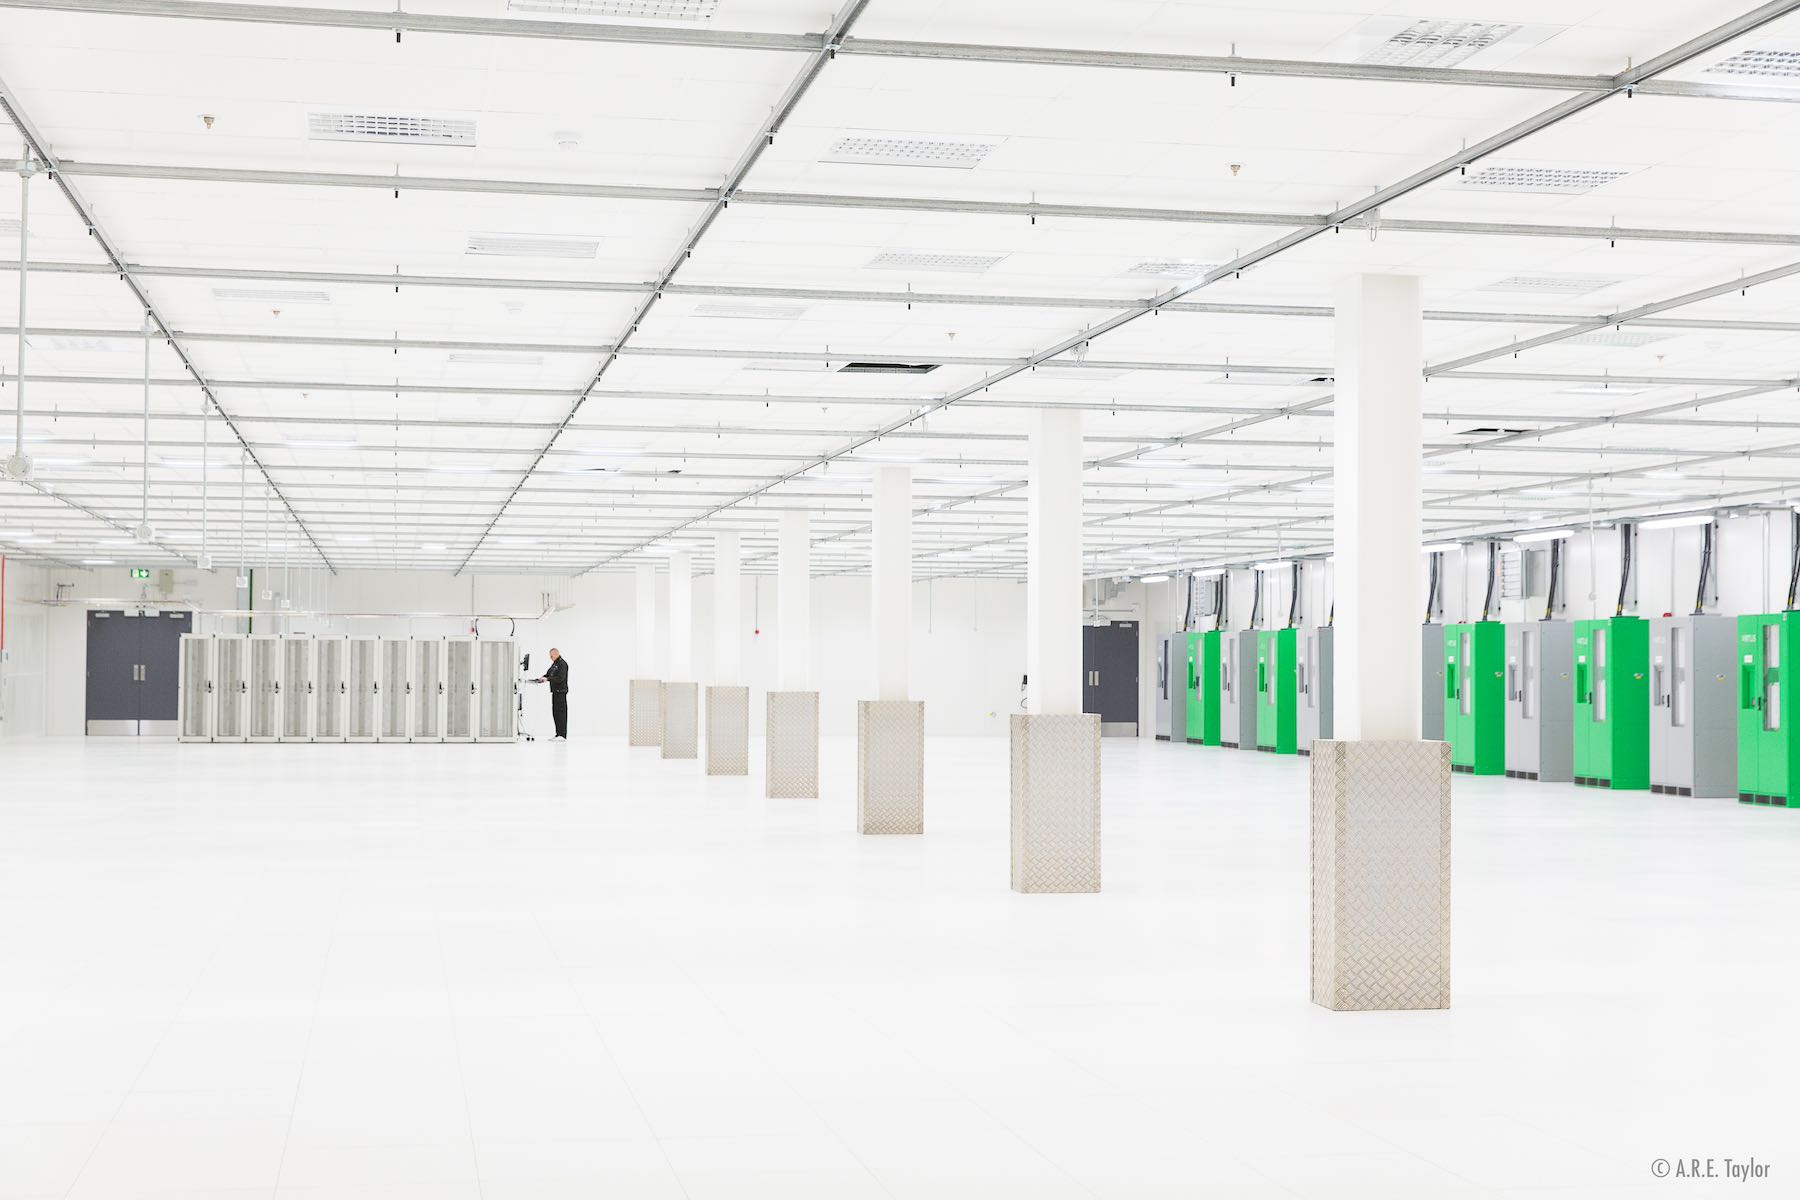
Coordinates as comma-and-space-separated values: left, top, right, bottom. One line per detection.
1012, 712, 1100, 892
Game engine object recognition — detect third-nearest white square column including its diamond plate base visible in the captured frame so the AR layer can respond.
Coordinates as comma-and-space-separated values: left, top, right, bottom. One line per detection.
857, 466, 925, 833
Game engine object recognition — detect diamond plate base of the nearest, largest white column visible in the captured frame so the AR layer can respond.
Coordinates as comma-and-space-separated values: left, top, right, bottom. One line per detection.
1312, 741, 1451, 1011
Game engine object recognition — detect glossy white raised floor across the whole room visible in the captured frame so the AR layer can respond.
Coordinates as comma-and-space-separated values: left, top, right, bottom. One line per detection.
0, 738, 1800, 1200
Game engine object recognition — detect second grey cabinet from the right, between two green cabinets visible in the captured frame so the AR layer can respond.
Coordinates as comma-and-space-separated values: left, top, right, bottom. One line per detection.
1504, 621, 1575, 783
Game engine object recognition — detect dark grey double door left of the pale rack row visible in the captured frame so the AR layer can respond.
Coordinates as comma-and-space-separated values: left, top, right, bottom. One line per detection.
88, 608, 194, 738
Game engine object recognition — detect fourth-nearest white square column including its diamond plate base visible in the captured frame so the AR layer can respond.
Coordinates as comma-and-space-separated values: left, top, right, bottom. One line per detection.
763, 509, 819, 799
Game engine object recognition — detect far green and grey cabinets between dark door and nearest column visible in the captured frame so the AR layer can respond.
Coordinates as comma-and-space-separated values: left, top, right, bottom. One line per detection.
1156, 626, 1332, 754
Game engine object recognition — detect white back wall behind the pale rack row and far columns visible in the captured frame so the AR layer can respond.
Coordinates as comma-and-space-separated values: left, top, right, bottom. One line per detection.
5, 569, 1024, 736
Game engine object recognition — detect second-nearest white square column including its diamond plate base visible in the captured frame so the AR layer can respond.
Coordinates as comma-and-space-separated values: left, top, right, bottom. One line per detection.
1012, 410, 1100, 892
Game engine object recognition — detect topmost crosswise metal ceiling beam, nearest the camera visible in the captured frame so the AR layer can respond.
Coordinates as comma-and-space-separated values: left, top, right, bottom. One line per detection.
0, 0, 1796, 101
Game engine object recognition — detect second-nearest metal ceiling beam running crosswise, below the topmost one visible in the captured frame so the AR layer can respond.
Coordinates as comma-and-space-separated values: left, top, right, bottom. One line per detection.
45, 161, 1800, 246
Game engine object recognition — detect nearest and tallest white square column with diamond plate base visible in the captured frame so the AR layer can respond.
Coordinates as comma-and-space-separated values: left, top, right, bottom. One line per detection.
1310, 275, 1451, 1009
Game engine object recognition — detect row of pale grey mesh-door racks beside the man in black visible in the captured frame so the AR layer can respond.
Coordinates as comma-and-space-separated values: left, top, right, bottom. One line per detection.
180, 633, 518, 741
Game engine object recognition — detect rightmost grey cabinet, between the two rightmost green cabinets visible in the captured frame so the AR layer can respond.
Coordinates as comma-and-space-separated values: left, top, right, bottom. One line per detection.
1651, 615, 1737, 797
